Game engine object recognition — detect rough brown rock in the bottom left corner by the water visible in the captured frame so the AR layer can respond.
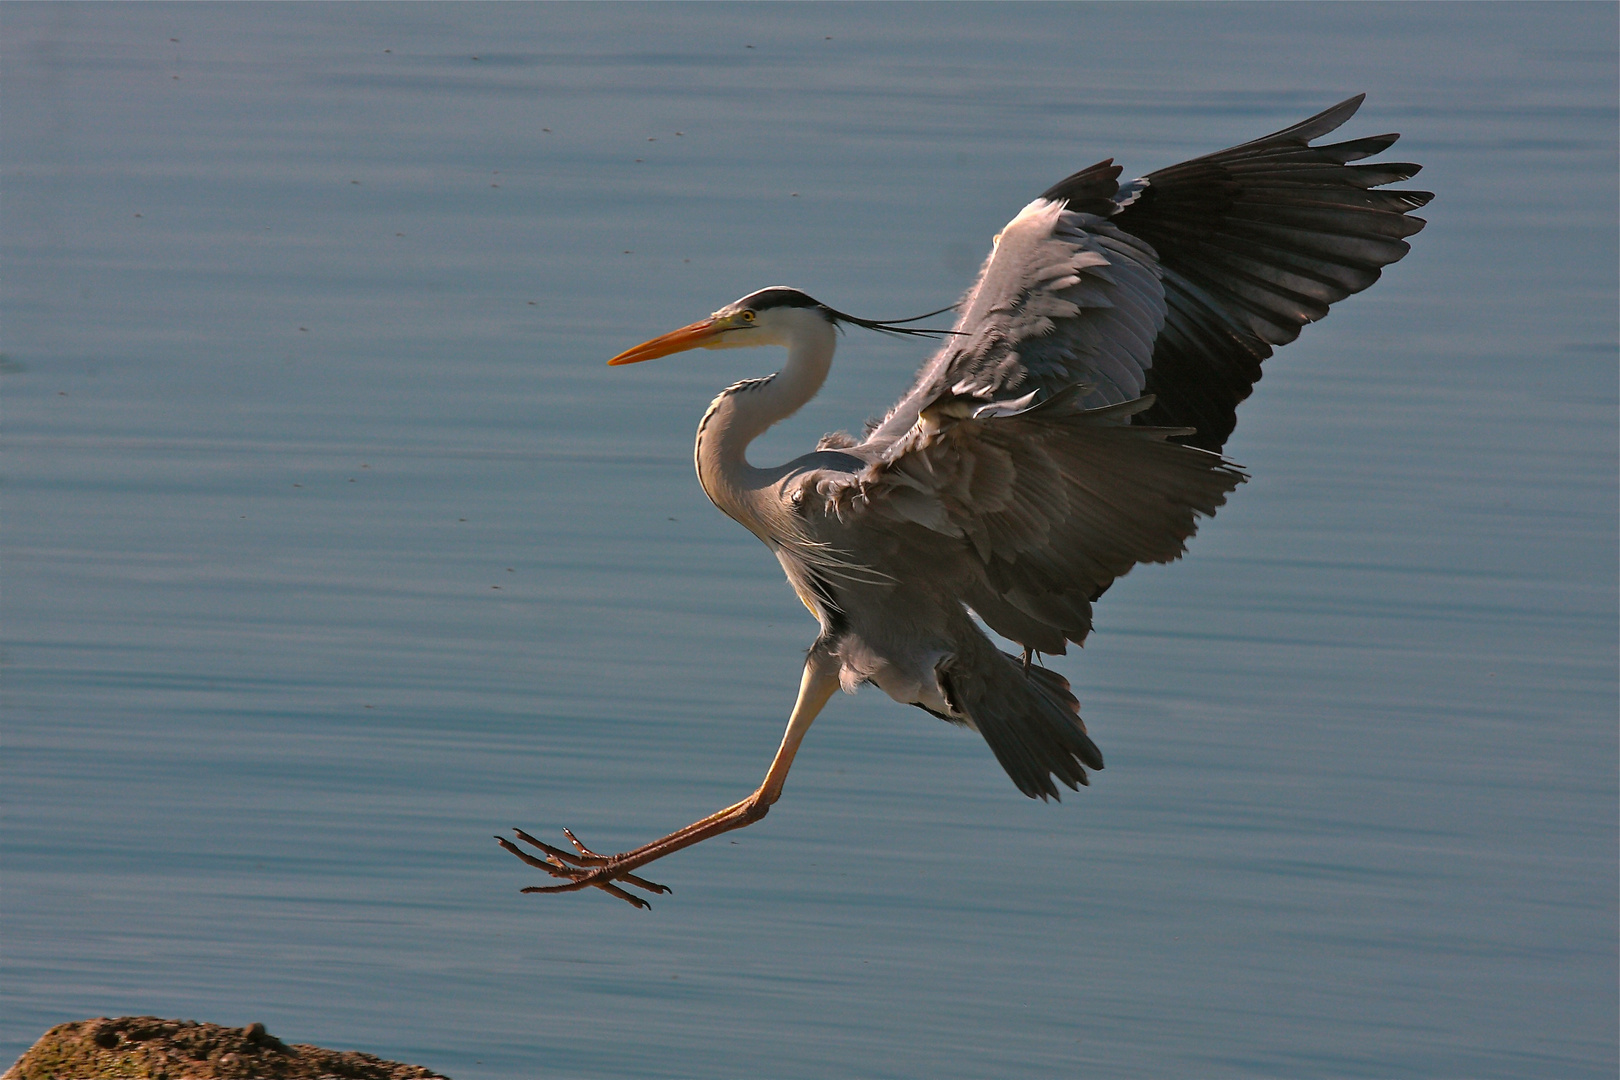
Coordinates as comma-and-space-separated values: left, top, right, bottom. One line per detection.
0, 1017, 447, 1080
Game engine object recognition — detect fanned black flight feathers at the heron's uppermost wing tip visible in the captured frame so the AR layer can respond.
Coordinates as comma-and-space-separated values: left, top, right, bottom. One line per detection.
1113, 94, 1434, 450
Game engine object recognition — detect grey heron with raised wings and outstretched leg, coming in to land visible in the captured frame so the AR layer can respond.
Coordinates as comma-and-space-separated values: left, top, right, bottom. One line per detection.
496, 96, 1432, 907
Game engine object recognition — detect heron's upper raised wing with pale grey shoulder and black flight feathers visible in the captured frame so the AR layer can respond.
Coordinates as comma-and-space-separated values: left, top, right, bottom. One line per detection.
867, 96, 1432, 452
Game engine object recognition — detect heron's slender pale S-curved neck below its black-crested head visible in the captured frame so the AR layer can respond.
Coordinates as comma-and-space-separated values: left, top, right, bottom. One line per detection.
692, 309, 838, 542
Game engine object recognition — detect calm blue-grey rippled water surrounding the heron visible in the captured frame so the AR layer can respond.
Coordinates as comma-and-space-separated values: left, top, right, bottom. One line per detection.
0, 5, 1620, 1080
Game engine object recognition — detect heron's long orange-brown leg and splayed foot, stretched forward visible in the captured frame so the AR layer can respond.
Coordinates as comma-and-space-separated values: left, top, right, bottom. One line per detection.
496, 651, 838, 907
